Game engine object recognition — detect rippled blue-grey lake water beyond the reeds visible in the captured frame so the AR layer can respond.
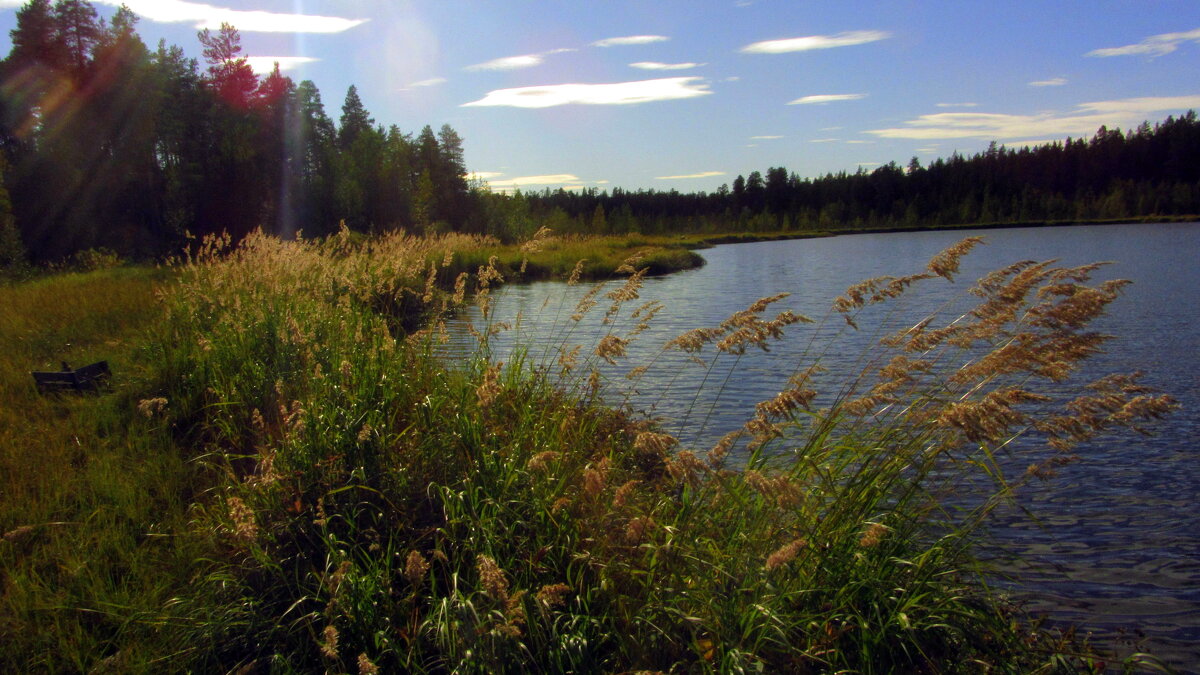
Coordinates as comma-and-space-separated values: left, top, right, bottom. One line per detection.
451, 223, 1200, 671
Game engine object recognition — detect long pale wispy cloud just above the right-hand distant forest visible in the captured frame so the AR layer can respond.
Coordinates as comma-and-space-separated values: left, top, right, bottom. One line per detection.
866, 95, 1200, 139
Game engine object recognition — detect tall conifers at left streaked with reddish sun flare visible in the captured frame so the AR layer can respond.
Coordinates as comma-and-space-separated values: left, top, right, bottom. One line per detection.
0, 0, 479, 264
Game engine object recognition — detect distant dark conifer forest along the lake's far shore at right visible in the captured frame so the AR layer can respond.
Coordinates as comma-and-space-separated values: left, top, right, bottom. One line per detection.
521, 117, 1200, 234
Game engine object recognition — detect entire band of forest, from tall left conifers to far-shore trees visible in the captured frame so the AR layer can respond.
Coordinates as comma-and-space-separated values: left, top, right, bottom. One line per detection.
0, 0, 1200, 267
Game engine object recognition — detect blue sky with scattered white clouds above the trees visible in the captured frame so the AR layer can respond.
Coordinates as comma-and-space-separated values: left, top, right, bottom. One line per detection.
0, 0, 1200, 192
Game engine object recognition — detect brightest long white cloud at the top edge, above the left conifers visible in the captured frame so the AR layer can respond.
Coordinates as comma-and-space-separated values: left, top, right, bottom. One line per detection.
85, 0, 367, 33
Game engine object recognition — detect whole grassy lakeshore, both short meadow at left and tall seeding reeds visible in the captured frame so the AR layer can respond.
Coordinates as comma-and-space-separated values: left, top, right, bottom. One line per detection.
0, 229, 1171, 673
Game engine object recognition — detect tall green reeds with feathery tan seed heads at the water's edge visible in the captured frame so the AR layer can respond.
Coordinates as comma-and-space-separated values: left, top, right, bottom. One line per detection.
129, 225, 1172, 673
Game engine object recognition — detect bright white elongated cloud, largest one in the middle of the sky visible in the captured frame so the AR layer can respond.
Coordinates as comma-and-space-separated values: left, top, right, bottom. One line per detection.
463, 77, 712, 108
